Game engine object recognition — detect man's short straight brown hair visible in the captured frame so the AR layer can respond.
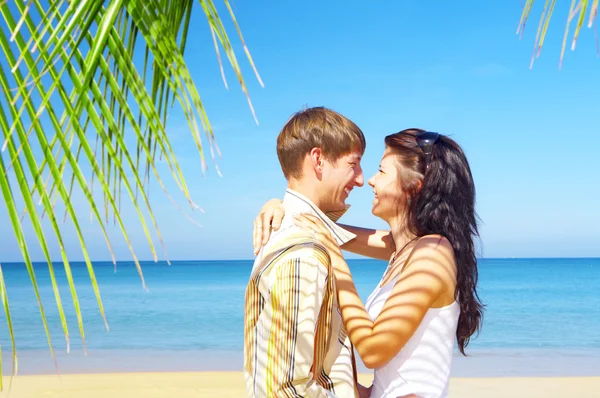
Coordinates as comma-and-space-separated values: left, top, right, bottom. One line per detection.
277, 107, 367, 180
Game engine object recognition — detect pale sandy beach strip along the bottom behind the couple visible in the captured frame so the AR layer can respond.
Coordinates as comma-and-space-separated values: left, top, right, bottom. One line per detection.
0, 372, 600, 398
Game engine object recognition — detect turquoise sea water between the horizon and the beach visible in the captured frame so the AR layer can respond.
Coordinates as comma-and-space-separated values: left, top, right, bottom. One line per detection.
0, 259, 600, 373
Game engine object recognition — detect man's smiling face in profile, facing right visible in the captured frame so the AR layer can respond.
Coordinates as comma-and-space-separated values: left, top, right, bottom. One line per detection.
320, 150, 364, 212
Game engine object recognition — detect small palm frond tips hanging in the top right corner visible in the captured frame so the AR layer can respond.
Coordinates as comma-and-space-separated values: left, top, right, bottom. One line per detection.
517, 0, 600, 69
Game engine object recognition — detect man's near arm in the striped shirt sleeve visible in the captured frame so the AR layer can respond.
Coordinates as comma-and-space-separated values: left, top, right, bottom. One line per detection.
255, 245, 333, 397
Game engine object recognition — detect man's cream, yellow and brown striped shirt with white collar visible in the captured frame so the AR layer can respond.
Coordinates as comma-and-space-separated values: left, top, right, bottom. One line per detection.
244, 189, 358, 398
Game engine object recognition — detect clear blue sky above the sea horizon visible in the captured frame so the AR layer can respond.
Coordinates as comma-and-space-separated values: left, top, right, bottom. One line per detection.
0, 0, 600, 261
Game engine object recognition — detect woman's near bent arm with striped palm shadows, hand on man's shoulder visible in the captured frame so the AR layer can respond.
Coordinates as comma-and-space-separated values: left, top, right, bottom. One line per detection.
296, 215, 456, 369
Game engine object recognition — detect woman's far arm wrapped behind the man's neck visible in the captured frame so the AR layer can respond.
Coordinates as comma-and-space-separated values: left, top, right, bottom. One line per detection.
252, 199, 395, 261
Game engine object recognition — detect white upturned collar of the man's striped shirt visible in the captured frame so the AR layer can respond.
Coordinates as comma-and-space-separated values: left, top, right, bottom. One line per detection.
283, 188, 356, 246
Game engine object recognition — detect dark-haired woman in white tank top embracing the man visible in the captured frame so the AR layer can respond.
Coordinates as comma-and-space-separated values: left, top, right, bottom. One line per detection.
255, 129, 483, 398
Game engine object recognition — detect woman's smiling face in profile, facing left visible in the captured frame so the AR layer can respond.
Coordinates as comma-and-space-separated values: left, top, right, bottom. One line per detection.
369, 148, 404, 222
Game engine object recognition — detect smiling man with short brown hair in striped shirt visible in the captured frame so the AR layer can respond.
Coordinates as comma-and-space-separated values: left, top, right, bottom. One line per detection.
244, 107, 366, 398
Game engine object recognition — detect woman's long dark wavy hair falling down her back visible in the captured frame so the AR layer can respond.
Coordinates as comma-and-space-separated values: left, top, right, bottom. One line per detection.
385, 129, 483, 355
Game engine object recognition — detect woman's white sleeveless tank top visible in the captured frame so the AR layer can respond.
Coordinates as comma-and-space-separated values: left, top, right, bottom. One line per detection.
366, 274, 460, 398
